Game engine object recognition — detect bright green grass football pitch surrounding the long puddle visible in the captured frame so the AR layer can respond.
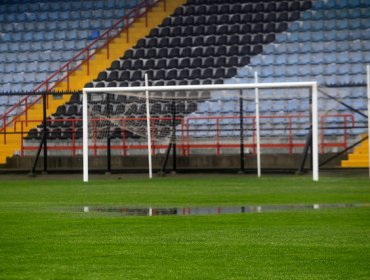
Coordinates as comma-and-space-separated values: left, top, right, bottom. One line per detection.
0, 174, 370, 279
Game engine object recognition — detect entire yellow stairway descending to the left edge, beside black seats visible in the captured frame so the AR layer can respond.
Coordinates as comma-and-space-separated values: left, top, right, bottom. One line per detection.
0, 0, 186, 164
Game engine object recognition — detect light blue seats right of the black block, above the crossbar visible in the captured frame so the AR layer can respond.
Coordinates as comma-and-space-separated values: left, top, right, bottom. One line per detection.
233, 1, 370, 86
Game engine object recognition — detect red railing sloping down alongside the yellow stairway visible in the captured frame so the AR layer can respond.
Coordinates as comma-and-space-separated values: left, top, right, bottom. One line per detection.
0, 0, 167, 138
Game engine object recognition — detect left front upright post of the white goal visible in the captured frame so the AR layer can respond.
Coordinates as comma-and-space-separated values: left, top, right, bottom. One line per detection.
82, 88, 89, 182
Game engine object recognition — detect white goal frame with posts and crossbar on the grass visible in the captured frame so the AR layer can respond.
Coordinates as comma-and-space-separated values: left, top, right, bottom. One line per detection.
82, 81, 319, 182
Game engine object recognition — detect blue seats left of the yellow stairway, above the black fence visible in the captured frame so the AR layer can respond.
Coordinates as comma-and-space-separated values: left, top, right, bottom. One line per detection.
0, 0, 137, 95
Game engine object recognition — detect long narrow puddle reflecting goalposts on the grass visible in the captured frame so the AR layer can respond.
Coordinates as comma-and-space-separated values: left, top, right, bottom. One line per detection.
82, 203, 370, 216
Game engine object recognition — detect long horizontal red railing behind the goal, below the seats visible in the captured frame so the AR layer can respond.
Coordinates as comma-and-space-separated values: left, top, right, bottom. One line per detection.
14, 114, 354, 156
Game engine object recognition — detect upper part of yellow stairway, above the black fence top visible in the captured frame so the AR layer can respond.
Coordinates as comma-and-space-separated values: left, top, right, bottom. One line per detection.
55, 0, 186, 91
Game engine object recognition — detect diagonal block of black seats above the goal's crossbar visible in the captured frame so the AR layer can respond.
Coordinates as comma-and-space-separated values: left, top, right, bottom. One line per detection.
87, 1, 311, 87
